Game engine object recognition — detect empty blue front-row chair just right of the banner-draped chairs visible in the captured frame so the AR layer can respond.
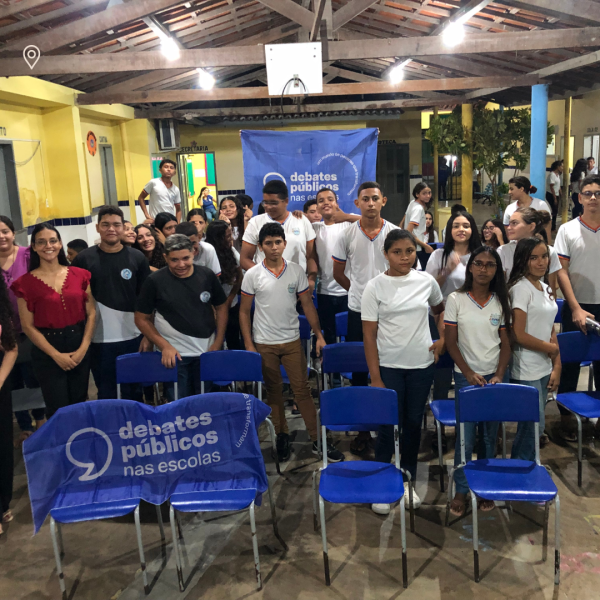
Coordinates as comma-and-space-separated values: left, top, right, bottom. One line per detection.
313, 387, 414, 587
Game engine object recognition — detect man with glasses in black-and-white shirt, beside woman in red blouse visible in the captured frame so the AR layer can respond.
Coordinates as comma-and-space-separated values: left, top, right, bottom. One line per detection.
72, 206, 150, 401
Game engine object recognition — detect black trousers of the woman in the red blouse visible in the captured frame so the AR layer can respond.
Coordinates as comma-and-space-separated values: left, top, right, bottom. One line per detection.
31, 322, 90, 418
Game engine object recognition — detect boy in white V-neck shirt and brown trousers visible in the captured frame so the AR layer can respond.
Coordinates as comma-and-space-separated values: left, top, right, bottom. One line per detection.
240, 223, 344, 462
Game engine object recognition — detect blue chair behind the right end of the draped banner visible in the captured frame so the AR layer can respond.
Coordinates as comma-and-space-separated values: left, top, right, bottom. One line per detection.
200, 350, 281, 475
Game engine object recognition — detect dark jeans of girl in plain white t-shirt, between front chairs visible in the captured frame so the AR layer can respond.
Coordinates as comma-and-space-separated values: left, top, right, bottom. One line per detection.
375, 364, 435, 481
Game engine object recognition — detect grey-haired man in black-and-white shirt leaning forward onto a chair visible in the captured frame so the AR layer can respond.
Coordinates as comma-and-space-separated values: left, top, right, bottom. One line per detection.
135, 233, 228, 401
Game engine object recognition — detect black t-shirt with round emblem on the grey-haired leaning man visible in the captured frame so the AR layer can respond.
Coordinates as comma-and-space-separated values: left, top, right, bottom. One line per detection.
136, 265, 227, 348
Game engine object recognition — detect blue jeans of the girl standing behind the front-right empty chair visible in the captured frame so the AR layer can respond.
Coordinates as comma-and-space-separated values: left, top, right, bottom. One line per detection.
454, 371, 498, 494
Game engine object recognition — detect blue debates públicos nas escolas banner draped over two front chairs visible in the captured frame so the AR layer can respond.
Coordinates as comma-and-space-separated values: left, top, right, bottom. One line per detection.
23, 393, 271, 533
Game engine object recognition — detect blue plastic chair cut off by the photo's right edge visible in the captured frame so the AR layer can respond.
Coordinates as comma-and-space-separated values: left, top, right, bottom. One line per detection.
556, 331, 600, 487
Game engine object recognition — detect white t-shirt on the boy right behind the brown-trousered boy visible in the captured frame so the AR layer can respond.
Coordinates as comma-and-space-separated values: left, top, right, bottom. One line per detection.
242, 213, 315, 271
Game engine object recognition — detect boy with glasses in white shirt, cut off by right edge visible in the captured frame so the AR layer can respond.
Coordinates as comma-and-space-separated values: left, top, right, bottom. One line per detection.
554, 175, 600, 424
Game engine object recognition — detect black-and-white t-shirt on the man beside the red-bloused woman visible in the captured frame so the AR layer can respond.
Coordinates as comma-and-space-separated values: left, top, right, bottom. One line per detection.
73, 246, 150, 343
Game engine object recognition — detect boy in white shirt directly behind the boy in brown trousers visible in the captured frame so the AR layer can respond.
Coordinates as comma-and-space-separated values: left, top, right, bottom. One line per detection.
240, 180, 317, 278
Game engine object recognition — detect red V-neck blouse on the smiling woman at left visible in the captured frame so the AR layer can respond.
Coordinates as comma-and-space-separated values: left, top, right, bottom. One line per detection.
10, 267, 92, 329
